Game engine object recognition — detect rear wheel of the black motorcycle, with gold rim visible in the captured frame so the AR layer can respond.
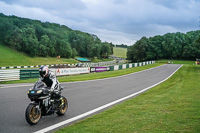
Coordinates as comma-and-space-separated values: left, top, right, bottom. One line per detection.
57, 96, 68, 116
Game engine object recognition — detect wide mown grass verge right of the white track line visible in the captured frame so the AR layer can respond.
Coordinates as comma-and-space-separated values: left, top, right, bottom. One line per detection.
56, 64, 200, 133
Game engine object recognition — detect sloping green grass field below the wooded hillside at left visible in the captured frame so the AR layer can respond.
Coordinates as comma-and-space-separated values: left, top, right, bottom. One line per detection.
0, 45, 78, 67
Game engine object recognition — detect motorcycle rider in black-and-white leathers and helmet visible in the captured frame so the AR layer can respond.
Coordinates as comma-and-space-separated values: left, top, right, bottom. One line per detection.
39, 66, 61, 99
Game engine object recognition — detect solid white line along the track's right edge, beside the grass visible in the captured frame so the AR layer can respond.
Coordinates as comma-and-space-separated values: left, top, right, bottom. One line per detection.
35, 65, 183, 133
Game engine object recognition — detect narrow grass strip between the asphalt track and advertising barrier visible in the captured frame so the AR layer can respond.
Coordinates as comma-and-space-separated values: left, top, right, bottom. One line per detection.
1, 63, 162, 84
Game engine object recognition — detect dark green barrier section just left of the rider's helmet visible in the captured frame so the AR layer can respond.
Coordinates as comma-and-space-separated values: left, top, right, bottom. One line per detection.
20, 69, 39, 80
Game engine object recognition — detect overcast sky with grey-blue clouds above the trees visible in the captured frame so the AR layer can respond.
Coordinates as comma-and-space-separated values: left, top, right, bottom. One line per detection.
0, 0, 200, 45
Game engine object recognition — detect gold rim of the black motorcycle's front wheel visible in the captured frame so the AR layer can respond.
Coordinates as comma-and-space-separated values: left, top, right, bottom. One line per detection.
29, 106, 41, 123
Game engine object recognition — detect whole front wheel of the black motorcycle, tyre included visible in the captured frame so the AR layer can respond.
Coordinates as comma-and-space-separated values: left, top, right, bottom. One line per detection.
25, 104, 41, 125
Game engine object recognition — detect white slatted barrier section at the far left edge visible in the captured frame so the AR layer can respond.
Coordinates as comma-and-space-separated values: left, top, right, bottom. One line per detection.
0, 69, 20, 81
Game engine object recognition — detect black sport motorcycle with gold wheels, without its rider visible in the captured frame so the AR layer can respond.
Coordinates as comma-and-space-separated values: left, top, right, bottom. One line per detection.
25, 81, 68, 125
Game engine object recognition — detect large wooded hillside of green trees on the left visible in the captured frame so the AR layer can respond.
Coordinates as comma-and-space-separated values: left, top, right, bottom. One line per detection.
0, 13, 113, 58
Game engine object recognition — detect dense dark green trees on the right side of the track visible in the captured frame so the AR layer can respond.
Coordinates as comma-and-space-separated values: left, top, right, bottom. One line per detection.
127, 30, 200, 61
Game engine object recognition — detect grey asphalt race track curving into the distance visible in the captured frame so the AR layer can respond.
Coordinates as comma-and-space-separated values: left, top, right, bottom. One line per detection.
0, 64, 181, 133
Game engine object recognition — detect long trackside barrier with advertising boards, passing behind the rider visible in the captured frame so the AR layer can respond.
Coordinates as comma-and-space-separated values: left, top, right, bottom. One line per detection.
0, 61, 155, 82
